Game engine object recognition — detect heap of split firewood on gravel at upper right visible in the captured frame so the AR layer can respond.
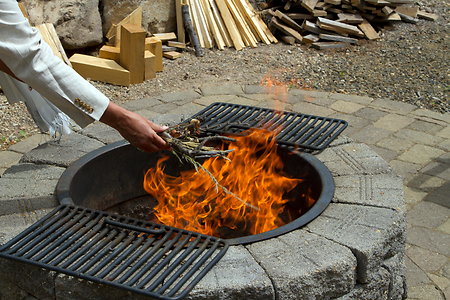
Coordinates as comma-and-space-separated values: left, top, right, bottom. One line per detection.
263, 0, 437, 49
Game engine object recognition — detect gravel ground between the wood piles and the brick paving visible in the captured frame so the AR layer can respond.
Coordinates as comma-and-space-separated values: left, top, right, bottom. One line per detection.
0, 0, 450, 149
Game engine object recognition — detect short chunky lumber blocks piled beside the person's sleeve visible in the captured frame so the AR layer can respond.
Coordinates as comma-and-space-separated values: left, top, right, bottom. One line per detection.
70, 7, 163, 86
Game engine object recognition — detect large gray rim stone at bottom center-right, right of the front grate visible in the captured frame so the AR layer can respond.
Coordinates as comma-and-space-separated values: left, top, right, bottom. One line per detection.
247, 230, 356, 299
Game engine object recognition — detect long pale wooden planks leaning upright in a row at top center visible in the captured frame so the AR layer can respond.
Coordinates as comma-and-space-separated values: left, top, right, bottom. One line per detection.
176, 0, 278, 50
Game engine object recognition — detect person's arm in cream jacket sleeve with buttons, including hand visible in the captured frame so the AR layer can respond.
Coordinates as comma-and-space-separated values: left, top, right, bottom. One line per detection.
0, 0, 168, 151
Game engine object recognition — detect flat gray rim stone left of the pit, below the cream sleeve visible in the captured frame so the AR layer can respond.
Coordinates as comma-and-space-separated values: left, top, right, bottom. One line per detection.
21, 133, 104, 167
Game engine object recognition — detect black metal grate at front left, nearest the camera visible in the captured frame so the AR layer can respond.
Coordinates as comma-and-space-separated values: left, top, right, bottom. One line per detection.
0, 205, 228, 299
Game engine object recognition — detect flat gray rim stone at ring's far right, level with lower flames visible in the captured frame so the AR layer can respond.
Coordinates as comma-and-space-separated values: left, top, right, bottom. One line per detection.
333, 174, 405, 211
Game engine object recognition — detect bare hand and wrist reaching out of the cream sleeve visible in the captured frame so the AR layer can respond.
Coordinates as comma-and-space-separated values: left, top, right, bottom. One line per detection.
100, 102, 170, 152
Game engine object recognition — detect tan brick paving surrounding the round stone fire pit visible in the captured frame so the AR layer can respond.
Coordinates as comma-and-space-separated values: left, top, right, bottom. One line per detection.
0, 85, 450, 300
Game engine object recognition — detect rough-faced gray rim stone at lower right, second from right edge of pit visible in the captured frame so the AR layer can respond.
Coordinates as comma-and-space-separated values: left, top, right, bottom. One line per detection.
307, 203, 405, 283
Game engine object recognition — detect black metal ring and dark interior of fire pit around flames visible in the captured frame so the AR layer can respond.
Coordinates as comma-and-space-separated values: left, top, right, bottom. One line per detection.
56, 141, 334, 245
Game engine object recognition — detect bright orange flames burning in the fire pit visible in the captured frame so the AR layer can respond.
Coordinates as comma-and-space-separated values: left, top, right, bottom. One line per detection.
144, 129, 301, 236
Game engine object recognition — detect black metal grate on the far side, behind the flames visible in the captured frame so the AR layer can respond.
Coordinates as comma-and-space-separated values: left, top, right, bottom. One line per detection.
190, 102, 348, 150
